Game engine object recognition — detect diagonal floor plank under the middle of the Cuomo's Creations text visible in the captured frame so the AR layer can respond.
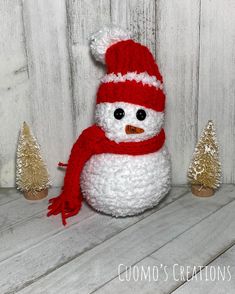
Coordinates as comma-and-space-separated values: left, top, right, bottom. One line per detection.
96, 186, 235, 294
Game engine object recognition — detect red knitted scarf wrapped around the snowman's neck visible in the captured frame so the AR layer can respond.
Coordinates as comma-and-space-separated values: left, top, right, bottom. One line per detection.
47, 125, 165, 225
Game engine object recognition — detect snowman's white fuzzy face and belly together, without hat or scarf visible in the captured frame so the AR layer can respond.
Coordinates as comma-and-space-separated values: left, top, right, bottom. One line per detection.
80, 102, 171, 217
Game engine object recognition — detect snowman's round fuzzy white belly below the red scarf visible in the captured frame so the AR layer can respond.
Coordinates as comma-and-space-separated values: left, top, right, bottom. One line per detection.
81, 147, 171, 217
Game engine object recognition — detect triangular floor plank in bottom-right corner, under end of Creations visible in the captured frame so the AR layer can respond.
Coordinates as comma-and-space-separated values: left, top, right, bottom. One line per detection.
172, 246, 235, 294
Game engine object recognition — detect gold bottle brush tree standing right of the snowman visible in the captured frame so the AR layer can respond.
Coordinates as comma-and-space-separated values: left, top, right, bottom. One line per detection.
188, 120, 221, 197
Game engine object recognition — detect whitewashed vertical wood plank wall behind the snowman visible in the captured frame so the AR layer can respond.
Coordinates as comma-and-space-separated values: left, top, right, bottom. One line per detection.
0, 0, 235, 187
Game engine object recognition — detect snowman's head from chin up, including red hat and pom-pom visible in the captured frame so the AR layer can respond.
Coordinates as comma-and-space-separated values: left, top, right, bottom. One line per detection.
91, 26, 165, 142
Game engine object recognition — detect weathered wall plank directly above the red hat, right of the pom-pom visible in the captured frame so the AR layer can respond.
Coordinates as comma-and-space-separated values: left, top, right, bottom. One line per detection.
111, 0, 156, 55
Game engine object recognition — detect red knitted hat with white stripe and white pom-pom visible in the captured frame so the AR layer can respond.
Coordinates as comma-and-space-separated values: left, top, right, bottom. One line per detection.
91, 26, 165, 111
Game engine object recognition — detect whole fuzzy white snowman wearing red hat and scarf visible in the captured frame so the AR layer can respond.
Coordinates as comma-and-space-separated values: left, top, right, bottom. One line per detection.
48, 27, 171, 224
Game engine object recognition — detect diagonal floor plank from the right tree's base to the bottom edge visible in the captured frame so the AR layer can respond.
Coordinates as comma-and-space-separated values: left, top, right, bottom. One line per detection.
17, 185, 234, 293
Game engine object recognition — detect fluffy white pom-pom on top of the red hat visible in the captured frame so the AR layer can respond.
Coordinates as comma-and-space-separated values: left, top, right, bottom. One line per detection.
90, 25, 131, 63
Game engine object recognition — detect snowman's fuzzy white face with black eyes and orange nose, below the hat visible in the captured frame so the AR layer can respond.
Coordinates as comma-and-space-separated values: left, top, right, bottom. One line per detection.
95, 102, 164, 142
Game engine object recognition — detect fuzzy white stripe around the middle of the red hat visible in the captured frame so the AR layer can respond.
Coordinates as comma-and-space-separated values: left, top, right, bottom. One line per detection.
101, 72, 163, 90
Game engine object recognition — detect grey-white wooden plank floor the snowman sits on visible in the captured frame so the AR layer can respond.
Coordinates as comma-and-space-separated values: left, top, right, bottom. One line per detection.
0, 185, 235, 294
